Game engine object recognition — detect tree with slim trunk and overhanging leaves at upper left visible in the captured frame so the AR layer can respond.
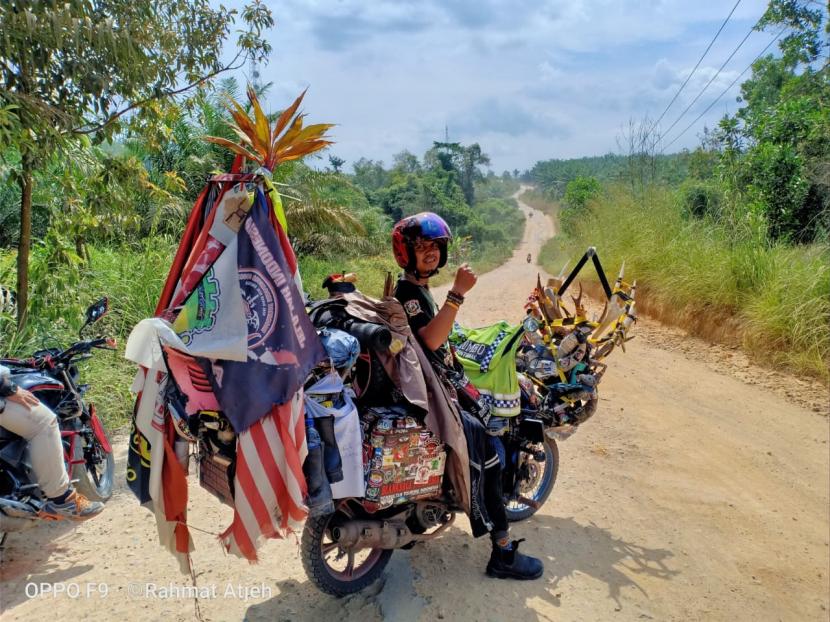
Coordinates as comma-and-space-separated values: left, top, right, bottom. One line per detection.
0, 0, 273, 328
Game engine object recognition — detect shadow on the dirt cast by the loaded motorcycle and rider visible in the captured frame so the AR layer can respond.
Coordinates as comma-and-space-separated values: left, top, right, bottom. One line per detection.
245, 515, 679, 622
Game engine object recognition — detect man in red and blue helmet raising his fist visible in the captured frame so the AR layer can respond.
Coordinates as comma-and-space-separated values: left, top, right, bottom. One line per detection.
392, 212, 544, 579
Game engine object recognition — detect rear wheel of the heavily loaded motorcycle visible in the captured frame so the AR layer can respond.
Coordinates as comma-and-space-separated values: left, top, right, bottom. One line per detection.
301, 511, 393, 598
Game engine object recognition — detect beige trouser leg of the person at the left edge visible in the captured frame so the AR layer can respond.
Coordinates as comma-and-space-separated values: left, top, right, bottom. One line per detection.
0, 400, 69, 498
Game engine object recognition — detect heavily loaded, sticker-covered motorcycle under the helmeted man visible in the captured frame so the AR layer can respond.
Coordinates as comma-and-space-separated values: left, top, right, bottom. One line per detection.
192, 251, 636, 597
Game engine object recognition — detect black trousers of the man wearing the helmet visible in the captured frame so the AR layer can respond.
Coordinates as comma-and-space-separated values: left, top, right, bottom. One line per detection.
461, 410, 508, 539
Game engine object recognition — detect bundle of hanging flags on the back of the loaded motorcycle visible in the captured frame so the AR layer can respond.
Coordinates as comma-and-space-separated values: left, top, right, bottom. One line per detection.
126, 175, 326, 572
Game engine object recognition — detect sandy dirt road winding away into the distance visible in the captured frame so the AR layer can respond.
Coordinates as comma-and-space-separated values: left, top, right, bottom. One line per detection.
0, 193, 830, 622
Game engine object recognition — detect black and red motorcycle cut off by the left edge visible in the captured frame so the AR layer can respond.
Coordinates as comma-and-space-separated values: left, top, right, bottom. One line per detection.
0, 298, 115, 539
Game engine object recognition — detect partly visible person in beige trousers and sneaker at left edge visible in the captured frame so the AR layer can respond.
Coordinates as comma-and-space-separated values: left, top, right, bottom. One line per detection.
0, 365, 104, 521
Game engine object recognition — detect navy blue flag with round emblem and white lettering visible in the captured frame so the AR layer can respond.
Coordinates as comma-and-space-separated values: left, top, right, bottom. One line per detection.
202, 188, 326, 434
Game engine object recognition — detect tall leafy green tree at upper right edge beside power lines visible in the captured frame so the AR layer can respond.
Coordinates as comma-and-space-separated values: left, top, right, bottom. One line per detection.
716, 0, 830, 242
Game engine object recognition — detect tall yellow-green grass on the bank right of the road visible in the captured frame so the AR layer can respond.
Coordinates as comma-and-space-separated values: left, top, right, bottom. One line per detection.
541, 183, 830, 382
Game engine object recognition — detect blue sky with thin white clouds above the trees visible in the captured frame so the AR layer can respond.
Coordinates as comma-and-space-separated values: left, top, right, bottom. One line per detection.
219, 0, 775, 173
